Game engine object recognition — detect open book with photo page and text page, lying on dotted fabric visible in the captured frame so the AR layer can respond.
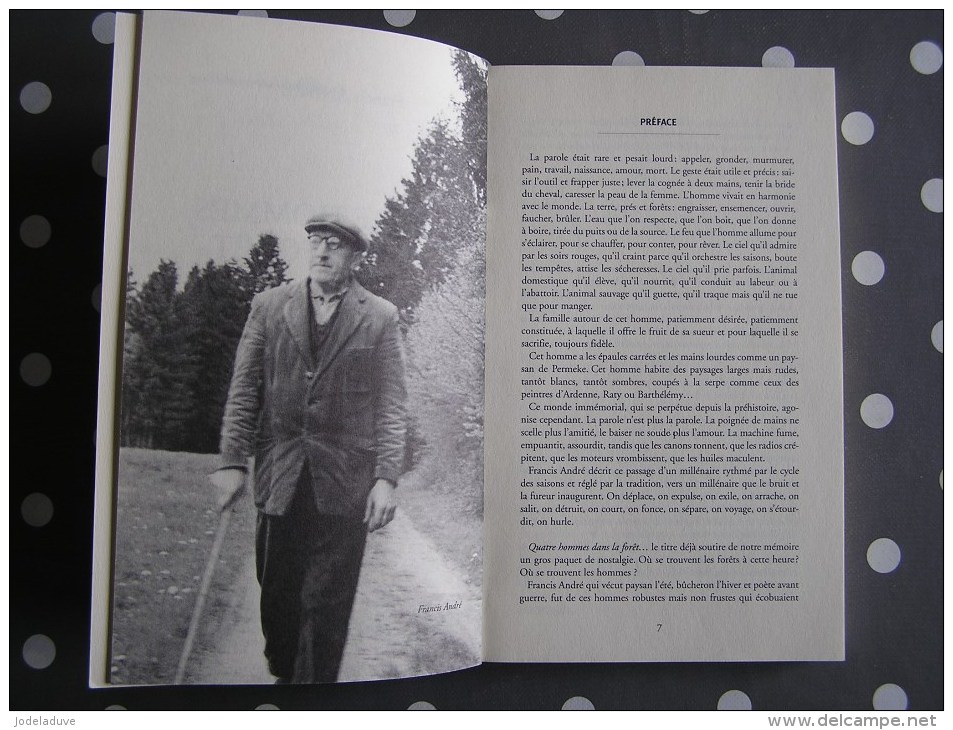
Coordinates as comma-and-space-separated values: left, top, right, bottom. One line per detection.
90, 12, 844, 686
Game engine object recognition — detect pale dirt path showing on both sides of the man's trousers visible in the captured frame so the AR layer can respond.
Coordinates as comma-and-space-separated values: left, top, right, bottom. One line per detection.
189, 512, 481, 684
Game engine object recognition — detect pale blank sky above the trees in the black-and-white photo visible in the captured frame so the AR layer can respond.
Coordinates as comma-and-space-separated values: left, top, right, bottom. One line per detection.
129, 13, 468, 285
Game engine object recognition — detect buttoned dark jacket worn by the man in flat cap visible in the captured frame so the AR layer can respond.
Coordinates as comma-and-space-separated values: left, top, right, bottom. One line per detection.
220, 281, 406, 515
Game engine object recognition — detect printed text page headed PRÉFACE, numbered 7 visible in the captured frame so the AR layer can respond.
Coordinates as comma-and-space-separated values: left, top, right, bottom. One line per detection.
485, 67, 844, 662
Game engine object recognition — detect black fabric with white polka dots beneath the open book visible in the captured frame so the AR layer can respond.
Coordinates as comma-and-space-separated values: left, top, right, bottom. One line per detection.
9, 10, 944, 711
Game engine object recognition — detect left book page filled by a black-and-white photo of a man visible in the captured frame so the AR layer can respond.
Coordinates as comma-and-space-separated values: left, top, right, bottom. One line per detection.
90, 12, 486, 686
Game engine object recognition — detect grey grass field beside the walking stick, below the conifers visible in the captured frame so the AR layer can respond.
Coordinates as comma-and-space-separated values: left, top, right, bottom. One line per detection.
110, 449, 254, 684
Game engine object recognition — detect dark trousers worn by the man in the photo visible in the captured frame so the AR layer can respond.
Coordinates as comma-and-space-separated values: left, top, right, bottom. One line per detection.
255, 468, 367, 684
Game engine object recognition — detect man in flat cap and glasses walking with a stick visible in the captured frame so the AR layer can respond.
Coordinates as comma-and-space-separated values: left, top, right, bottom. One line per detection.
212, 215, 406, 683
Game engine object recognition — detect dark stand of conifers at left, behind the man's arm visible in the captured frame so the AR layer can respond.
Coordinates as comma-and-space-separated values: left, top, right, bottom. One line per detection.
120, 234, 288, 453
